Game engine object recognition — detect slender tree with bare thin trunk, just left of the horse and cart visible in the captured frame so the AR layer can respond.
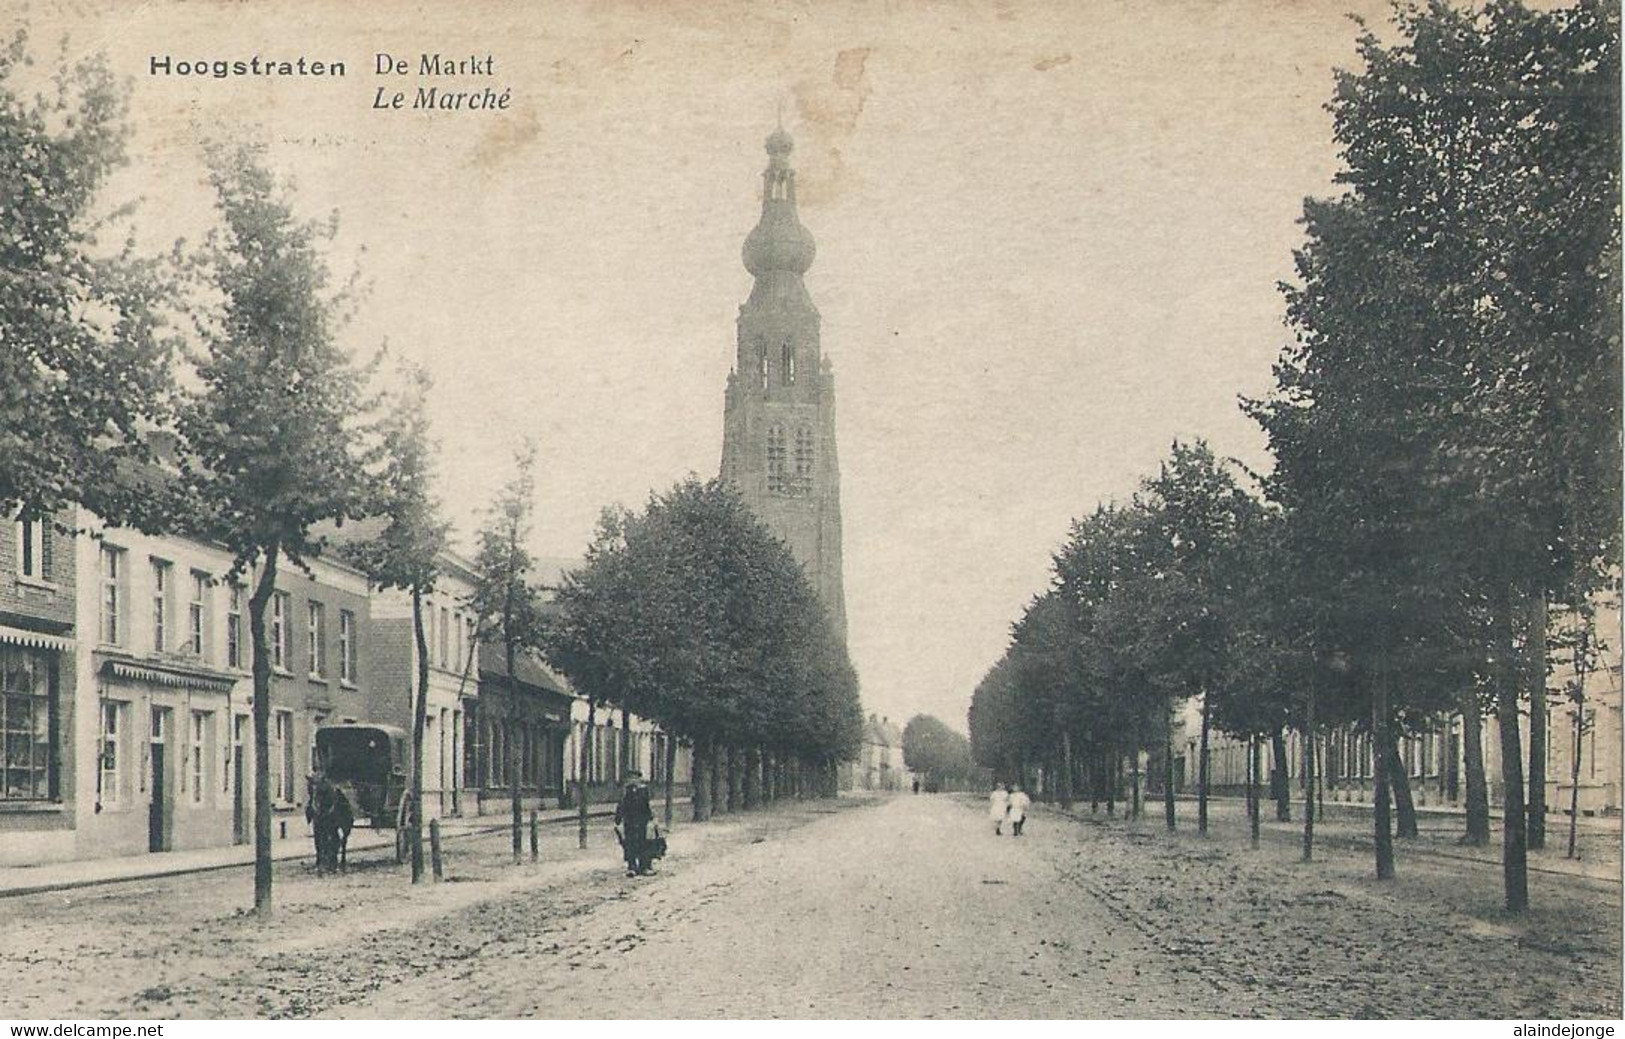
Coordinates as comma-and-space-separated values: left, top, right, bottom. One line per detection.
172, 139, 372, 915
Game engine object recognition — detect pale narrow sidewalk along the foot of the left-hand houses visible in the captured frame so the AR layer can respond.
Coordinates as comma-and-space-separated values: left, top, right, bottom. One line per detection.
0, 798, 689, 899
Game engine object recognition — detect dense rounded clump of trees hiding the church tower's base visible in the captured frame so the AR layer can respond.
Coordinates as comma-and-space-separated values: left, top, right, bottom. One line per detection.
546, 478, 863, 839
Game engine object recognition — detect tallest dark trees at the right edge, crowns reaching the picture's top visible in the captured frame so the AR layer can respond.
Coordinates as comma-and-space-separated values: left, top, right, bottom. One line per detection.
1261, 0, 1620, 911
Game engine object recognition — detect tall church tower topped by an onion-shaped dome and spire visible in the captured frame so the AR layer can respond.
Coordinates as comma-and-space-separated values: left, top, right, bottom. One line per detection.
722, 128, 847, 641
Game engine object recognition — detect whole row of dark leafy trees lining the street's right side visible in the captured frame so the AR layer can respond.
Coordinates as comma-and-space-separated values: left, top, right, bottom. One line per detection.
972, 0, 1622, 911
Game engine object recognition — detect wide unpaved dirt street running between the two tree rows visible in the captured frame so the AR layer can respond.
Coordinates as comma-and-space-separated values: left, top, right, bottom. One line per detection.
0, 795, 1620, 1018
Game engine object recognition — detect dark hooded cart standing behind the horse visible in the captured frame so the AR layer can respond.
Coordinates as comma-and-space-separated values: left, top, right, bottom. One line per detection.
312, 722, 414, 859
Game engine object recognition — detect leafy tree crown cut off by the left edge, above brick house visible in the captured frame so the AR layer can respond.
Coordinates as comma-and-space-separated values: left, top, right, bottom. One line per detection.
0, 31, 176, 528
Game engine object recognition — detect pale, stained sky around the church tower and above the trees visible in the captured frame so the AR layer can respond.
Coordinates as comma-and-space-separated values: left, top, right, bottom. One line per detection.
25, 0, 1386, 741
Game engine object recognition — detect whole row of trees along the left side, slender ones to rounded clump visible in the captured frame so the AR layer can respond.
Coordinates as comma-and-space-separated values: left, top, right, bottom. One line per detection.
0, 24, 858, 914
